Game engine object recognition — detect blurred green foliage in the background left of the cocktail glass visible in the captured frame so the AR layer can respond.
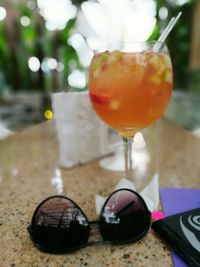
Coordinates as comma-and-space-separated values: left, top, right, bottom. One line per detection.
0, 1, 81, 93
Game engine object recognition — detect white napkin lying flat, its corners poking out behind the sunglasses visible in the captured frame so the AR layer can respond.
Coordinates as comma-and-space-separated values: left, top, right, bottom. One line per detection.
95, 173, 159, 214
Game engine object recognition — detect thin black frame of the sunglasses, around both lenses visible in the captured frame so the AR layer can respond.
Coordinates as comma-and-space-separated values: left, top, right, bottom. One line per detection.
27, 188, 151, 254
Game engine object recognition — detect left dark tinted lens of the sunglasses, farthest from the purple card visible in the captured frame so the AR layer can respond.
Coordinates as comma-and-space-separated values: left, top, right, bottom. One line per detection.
30, 196, 90, 253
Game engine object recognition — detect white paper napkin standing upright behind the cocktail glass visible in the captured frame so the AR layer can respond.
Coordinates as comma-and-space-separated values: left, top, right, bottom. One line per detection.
51, 91, 119, 168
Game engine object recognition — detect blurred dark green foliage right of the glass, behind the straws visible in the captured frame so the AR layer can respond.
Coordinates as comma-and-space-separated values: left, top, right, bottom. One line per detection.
150, 0, 200, 92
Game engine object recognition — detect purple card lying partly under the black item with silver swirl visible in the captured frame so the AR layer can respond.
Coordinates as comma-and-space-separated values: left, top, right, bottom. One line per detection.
160, 188, 200, 267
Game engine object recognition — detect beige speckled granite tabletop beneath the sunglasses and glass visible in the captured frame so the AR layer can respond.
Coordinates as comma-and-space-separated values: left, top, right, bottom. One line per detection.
0, 119, 200, 267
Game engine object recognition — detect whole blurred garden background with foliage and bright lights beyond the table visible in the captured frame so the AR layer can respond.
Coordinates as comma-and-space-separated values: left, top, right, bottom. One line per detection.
0, 0, 200, 131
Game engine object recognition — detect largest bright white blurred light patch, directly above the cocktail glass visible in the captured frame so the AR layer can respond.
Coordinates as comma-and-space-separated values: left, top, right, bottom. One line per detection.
77, 0, 156, 50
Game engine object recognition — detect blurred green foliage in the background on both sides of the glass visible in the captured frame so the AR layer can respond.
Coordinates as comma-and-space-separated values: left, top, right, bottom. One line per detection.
0, 0, 200, 93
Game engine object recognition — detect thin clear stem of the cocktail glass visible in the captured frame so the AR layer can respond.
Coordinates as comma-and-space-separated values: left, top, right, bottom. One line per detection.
122, 137, 133, 181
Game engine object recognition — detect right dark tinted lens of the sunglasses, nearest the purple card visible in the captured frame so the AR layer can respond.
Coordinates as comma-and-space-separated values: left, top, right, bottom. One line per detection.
100, 189, 151, 242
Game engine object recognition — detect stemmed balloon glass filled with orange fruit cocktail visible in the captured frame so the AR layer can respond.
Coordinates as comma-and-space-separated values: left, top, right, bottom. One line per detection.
89, 42, 173, 180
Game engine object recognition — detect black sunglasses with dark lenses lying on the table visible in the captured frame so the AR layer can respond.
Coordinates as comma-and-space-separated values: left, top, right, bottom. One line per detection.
28, 189, 151, 254
